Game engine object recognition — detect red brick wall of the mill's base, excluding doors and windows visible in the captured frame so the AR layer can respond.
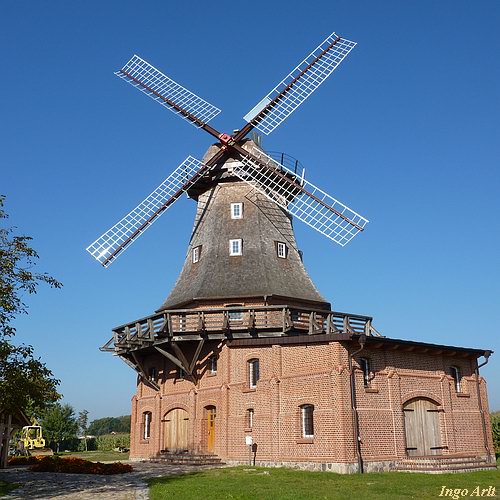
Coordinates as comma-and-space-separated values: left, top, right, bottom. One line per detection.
127, 337, 493, 463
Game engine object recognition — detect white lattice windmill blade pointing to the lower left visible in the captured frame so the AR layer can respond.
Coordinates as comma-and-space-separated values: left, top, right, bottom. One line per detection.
87, 156, 208, 267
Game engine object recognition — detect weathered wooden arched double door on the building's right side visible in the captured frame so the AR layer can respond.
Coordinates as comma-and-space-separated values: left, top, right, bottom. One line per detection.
403, 398, 442, 457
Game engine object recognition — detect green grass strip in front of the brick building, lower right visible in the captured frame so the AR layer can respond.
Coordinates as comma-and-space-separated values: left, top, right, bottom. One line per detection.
149, 467, 500, 500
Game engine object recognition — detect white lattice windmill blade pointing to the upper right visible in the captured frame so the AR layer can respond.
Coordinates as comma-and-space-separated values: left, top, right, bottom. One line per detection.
243, 33, 356, 135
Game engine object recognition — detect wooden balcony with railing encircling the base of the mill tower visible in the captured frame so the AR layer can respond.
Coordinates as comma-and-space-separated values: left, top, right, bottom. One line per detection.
101, 305, 380, 355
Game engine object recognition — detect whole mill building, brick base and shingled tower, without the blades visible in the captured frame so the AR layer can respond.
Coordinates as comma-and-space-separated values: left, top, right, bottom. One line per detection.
104, 142, 494, 472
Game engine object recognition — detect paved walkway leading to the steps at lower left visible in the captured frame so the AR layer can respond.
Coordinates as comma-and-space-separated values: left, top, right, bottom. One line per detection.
0, 462, 213, 500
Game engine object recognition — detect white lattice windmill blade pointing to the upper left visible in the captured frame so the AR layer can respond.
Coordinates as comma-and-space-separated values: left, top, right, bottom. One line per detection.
115, 55, 221, 128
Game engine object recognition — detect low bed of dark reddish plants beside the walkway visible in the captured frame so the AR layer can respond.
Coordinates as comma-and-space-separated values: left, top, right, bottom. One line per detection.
30, 456, 132, 475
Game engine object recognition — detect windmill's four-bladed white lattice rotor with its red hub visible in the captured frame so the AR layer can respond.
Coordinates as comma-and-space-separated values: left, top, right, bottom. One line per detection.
87, 33, 368, 268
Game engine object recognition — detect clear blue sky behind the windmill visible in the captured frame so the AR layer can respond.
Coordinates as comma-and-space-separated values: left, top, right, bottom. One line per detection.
0, 0, 500, 418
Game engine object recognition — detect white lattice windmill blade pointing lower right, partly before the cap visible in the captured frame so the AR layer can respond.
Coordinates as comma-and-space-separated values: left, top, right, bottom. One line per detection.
233, 150, 368, 246
